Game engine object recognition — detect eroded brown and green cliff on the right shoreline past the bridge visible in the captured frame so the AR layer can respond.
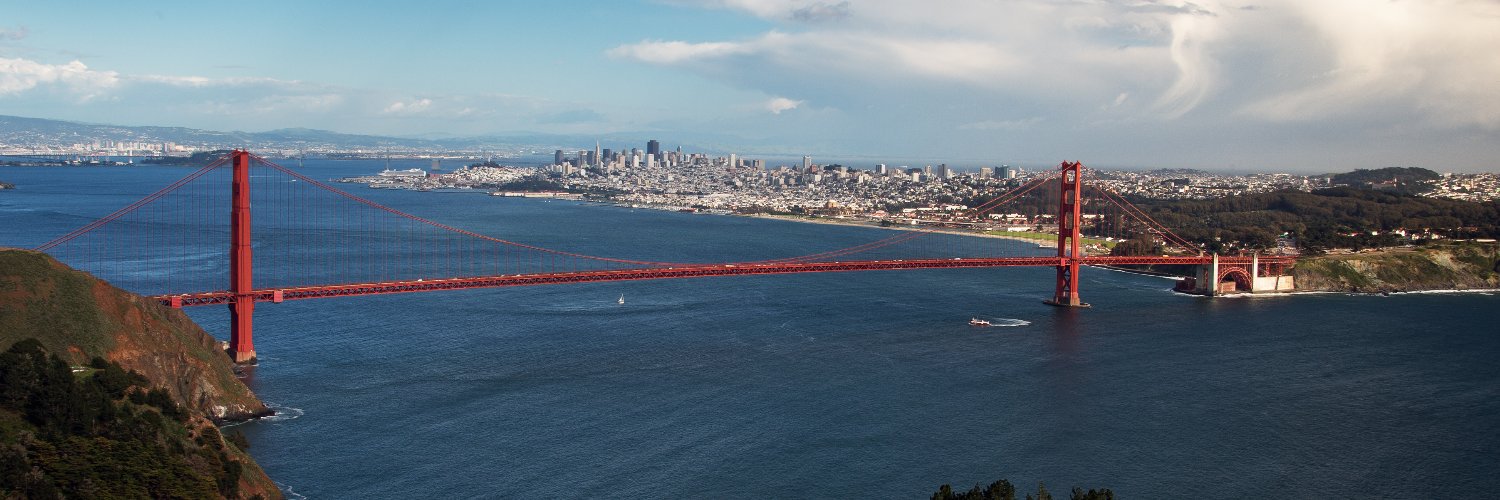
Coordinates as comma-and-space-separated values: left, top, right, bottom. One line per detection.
1292, 245, 1500, 293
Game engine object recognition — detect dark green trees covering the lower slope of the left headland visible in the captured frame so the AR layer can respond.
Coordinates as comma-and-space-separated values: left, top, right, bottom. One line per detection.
0, 339, 259, 498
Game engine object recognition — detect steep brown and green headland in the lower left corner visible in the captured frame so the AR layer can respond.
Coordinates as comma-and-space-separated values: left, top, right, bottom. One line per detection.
0, 248, 282, 498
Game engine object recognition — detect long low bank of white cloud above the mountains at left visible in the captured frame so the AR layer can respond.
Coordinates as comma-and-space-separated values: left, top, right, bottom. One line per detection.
0, 59, 588, 134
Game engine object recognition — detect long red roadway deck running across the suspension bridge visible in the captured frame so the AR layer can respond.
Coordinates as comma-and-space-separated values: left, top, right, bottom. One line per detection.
150, 255, 1295, 308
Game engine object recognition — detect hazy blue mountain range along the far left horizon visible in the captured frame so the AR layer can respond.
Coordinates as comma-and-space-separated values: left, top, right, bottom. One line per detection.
0, 116, 750, 153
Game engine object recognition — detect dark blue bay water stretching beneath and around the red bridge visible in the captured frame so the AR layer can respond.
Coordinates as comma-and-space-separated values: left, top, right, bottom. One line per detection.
0, 161, 1500, 498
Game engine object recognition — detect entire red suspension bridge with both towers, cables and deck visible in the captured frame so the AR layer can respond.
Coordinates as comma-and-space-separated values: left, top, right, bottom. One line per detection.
36, 150, 1293, 363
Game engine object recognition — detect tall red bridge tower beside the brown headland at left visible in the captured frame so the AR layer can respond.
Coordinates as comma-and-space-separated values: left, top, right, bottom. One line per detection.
230, 150, 255, 363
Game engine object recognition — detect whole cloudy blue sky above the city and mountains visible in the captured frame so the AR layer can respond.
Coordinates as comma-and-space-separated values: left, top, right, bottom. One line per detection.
0, 0, 1500, 173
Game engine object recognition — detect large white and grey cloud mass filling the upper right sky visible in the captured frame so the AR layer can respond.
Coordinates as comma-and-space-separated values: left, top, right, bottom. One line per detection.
609, 0, 1500, 128
